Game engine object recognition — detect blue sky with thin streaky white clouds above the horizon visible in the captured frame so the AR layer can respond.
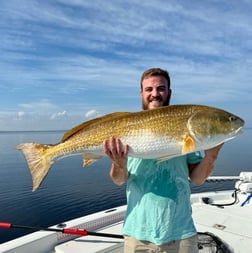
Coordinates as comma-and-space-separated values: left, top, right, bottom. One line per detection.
0, 0, 252, 131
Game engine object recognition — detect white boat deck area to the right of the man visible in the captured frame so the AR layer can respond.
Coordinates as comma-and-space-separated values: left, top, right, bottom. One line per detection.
192, 191, 252, 253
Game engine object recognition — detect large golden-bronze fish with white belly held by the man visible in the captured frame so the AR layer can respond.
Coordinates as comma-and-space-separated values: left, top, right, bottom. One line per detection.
17, 105, 244, 190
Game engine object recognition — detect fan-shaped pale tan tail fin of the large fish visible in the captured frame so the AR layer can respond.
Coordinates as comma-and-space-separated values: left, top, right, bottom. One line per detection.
17, 143, 54, 191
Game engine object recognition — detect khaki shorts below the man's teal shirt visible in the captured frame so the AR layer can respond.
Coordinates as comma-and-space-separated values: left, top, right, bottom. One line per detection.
124, 235, 199, 253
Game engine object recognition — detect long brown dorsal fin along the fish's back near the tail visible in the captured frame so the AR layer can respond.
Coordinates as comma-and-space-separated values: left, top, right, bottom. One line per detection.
61, 112, 132, 142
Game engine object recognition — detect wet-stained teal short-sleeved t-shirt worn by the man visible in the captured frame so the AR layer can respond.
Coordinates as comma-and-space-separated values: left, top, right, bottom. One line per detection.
123, 152, 202, 245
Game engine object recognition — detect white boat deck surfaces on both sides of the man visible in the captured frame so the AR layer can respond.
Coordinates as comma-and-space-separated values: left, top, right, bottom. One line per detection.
55, 191, 252, 253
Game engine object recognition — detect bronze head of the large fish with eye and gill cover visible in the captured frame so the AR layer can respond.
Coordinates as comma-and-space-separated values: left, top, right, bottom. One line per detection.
187, 107, 244, 148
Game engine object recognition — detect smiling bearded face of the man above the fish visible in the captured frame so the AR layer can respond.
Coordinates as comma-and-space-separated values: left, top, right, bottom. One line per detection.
140, 76, 171, 110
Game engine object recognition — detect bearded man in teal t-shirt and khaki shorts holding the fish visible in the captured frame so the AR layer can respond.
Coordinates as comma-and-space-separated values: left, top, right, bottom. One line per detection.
103, 68, 222, 253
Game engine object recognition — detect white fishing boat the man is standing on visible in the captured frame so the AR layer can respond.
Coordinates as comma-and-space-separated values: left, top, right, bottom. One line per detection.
0, 172, 252, 253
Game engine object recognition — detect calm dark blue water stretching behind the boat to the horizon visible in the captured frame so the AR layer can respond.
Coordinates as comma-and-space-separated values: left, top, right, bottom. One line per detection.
0, 129, 252, 243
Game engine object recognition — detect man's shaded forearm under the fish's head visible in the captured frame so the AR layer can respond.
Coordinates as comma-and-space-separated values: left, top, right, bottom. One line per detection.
189, 143, 223, 185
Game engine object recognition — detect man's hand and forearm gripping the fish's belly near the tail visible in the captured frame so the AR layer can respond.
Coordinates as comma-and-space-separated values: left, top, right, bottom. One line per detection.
102, 137, 129, 185
